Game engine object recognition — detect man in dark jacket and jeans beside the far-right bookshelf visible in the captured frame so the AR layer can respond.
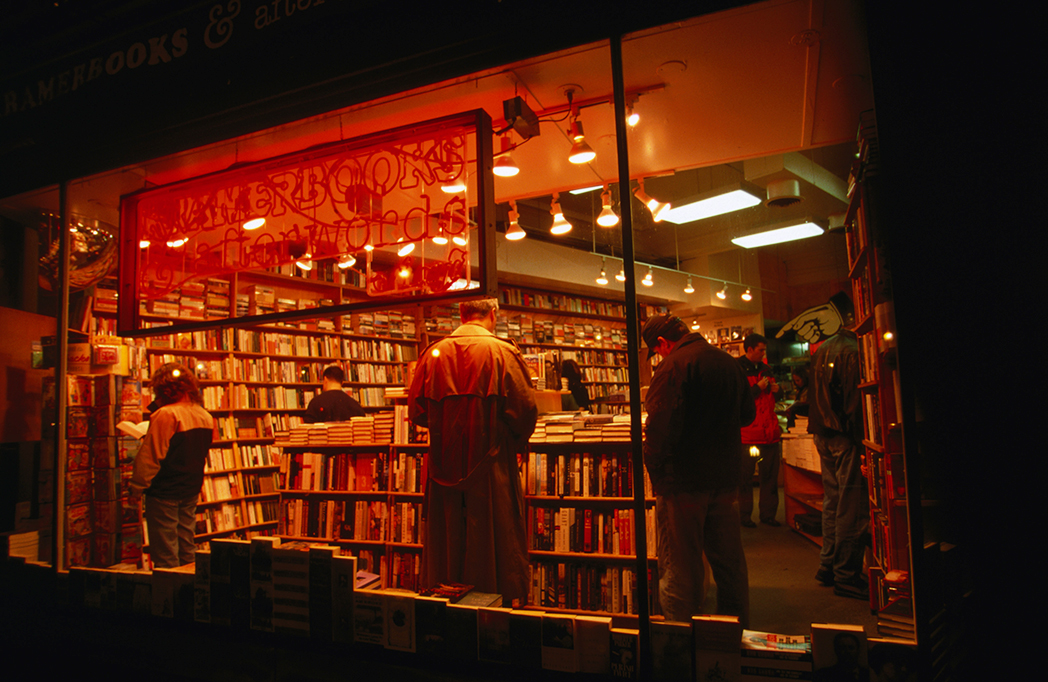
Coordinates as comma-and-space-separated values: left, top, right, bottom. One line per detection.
808, 294, 870, 599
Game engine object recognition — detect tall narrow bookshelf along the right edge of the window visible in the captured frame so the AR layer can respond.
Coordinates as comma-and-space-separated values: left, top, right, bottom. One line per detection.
846, 113, 914, 638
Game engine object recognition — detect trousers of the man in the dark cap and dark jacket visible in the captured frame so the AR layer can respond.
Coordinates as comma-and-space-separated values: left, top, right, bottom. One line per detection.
655, 487, 749, 628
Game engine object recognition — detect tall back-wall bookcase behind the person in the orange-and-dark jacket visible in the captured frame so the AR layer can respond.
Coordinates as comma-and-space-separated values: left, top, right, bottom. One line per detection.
134, 265, 418, 542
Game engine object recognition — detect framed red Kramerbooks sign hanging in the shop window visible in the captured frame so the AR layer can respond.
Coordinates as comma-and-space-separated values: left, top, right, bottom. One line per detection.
119, 110, 496, 335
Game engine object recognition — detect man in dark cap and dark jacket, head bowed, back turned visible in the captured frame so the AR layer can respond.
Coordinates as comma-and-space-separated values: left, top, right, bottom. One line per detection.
641, 314, 757, 628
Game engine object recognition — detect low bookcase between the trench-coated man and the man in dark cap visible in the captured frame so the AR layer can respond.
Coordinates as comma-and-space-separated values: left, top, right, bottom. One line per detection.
522, 431, 658, 615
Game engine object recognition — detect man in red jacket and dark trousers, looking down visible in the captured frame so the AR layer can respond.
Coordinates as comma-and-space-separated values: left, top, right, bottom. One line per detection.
739, 334, 782, 528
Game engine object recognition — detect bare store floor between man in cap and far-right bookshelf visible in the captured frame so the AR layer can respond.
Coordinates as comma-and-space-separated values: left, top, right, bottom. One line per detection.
733, 489, 877, 637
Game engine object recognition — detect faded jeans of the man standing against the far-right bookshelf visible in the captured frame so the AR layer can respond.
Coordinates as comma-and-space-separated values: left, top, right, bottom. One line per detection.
813, 434, 870, 584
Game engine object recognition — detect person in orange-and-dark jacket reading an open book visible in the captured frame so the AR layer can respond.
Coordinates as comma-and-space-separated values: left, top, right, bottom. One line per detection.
130, 362, 215, 568
